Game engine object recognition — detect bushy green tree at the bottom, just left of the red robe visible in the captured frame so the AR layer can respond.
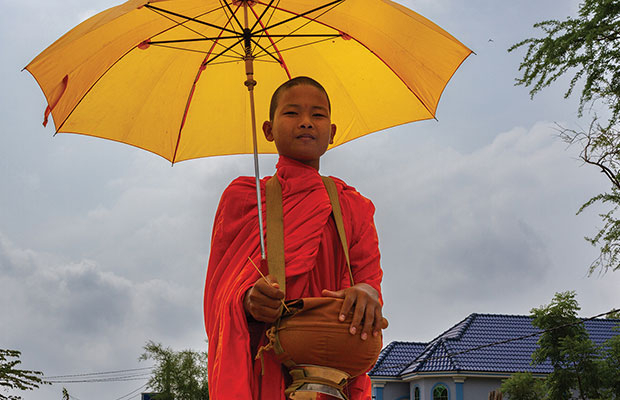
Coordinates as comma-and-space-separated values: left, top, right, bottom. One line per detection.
140, 341, 209, 400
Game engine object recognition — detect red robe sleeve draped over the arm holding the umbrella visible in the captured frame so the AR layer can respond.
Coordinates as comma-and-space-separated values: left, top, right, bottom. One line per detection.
204, 180, 258, 400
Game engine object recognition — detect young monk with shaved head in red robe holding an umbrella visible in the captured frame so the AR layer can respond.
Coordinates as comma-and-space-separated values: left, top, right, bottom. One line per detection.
204, 77, 383, 400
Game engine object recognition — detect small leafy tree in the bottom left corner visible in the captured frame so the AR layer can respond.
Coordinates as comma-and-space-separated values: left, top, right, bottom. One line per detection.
0, 349, 48, 400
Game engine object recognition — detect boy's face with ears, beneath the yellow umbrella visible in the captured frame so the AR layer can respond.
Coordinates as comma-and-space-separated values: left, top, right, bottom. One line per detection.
263, 84, 336, 169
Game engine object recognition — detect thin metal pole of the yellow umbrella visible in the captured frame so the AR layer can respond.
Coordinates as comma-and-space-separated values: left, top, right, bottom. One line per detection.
243, 1, 267, 260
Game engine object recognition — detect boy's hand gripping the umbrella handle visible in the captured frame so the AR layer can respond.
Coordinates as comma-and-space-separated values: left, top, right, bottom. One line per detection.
243, 275, 284, 323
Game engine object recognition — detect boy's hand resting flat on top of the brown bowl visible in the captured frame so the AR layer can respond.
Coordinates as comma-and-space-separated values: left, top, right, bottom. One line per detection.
322, 283, 387, 340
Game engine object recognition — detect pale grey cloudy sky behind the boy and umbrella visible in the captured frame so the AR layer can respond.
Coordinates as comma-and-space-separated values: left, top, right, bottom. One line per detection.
0, 0, 620, 400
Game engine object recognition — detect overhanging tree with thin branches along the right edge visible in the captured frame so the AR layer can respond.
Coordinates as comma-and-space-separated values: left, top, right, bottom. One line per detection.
508, 0, 620, 273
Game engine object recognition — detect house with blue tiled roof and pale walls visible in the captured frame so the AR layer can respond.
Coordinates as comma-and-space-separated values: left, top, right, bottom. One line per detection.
368, 314, 620, 400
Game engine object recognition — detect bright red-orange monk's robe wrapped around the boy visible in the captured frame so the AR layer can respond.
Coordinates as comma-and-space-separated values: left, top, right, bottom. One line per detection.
204, 156, 383, 400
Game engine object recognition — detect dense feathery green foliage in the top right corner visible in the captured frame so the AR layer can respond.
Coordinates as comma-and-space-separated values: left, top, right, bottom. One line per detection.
508, 0, 620, 123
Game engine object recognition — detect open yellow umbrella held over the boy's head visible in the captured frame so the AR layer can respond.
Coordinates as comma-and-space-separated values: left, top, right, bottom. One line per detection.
25, 0, 471, 258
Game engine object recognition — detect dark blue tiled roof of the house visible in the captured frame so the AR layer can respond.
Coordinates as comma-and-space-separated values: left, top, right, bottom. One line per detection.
369, 314, 620, 377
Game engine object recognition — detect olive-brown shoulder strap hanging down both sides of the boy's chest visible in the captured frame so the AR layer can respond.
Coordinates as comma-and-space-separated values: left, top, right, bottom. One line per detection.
265, 175, 355, 293
